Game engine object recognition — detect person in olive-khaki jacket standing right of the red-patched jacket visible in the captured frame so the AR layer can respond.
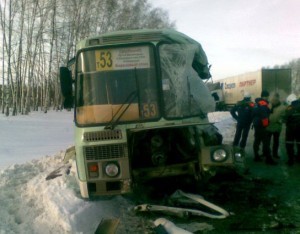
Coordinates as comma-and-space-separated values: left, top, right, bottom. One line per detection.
267, 93, 285, 159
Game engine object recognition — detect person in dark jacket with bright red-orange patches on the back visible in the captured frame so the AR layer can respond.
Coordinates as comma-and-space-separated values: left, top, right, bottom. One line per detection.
253, 90, 276, 165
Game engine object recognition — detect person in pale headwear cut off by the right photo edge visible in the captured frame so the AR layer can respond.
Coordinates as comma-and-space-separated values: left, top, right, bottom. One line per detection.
285, 94, 300, 166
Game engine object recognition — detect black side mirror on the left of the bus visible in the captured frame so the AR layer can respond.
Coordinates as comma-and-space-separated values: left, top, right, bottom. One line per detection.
59, 67, 73, 109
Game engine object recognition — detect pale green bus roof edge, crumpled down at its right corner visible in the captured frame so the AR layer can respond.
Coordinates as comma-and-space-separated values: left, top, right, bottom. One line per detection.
77, 29, 211, 79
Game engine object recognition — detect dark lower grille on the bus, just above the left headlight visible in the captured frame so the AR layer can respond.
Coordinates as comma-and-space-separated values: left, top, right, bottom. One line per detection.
83, 144, 128, 161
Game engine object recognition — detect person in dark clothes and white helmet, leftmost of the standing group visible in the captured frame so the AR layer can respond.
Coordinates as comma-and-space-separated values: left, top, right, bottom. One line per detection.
230, 92, 254, 150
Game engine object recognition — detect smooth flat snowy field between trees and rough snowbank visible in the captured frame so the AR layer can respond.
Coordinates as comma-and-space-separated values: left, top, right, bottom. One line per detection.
0, 111, 74, 170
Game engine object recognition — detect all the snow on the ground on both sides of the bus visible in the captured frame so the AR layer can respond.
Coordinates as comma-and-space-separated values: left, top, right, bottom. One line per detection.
0, 111, 234, 234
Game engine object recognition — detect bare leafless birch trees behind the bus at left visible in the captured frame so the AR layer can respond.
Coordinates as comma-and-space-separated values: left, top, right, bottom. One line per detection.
0, 0, 175, 116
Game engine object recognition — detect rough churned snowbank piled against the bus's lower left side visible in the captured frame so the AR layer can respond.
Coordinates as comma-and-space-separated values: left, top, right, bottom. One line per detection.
0, 153, 126, 233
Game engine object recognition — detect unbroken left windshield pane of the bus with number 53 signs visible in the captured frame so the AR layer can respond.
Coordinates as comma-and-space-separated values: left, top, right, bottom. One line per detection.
76, 45, 159, 125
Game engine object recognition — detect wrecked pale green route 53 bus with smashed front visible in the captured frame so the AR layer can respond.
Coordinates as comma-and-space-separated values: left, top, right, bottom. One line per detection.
60, 29, 243, 198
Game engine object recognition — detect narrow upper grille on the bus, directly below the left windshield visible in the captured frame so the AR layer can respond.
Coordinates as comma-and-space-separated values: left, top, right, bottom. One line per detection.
83, 129, 122, 142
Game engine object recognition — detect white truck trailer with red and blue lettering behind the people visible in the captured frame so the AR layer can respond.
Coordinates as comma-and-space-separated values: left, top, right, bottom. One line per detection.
209, 68, 292, 109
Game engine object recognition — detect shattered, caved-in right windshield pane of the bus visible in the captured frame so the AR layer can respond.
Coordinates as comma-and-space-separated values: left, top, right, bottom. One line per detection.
159, 44, 215, 118
